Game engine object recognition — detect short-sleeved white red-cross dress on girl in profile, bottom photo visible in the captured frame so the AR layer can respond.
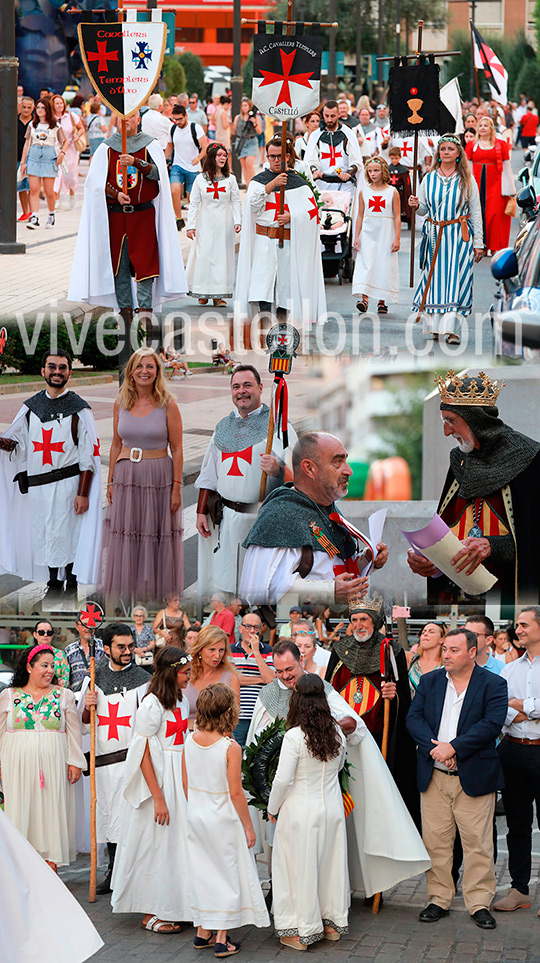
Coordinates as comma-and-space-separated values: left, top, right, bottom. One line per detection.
111, 693, 191, 922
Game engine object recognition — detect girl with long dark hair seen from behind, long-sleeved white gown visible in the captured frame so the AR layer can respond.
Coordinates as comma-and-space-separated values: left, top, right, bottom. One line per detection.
268, 673, 350, 950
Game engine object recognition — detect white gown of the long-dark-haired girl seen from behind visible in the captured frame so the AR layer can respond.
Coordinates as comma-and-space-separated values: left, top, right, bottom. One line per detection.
268, 726, 351, 944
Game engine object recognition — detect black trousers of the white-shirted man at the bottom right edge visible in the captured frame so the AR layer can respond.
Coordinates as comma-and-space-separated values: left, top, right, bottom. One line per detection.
498, 739, 540, 896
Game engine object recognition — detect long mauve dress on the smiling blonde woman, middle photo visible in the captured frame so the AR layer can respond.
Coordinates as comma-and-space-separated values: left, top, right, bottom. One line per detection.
103, 408, 184, 603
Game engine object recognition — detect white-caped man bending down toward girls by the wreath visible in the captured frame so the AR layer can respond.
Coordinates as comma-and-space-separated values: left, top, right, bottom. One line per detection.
246, 640, 430, 897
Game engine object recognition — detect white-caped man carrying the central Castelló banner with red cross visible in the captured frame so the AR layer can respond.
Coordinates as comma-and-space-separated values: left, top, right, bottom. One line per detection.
235, 137, 326, 324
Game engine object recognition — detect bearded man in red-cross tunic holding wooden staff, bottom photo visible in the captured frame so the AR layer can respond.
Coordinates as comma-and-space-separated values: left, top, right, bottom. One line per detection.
79, 622, 150, 896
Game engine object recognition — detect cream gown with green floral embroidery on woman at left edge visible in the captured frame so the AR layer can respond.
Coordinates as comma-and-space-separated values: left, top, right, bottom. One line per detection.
0, 686, 86, 866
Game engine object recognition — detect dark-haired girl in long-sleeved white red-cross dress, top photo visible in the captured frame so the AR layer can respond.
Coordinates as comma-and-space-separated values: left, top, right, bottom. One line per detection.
186, 144, 242, 307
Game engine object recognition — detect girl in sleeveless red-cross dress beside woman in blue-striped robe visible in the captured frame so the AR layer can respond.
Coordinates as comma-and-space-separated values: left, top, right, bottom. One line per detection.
352, 157, 401, 314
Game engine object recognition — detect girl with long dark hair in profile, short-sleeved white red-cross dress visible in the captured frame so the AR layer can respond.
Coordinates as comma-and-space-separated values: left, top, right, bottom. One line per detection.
111, 645, 191, 934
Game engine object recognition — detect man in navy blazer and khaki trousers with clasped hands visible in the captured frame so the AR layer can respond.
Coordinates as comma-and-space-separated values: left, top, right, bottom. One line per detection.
407, 629, 508, 929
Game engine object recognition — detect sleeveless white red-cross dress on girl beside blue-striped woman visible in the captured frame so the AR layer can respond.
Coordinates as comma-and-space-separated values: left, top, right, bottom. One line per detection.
352, 183, 399, 304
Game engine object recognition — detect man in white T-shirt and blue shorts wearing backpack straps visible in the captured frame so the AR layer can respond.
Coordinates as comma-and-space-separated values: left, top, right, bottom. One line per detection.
165, 104, 208, 220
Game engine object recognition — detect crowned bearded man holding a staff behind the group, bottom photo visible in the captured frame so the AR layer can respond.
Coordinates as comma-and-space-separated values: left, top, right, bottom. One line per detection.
326, 597, 420, 825
